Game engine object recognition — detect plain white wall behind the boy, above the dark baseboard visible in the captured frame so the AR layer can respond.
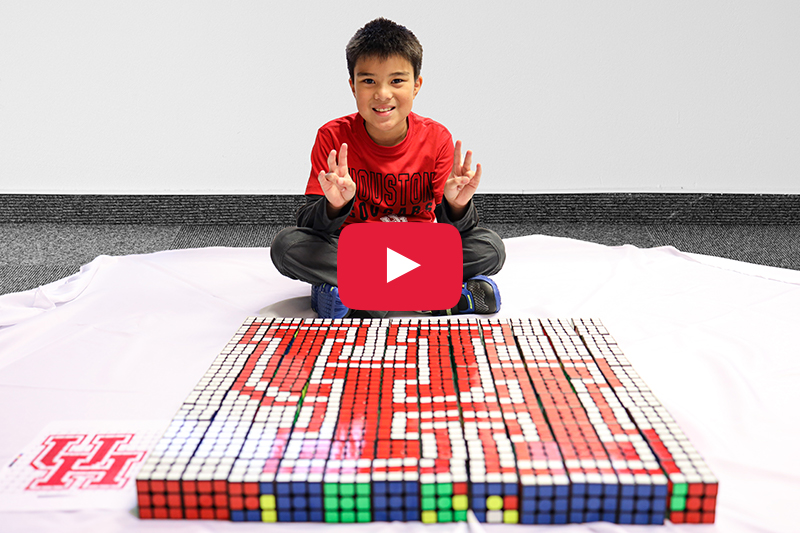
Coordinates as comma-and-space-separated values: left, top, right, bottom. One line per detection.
0, 0, 800, 194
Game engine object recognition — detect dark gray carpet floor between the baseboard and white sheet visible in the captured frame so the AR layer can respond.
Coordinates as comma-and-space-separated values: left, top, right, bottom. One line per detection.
0, 222, 800, 294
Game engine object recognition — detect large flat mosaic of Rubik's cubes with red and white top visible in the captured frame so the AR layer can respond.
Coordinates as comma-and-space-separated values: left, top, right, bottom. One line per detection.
137, 318, 718, 524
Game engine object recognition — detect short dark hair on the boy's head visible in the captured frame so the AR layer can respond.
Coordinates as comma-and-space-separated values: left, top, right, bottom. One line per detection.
345, 17, 422, 80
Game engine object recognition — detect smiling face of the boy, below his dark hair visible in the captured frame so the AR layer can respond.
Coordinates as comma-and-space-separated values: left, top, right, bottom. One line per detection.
350, 56, 422, 146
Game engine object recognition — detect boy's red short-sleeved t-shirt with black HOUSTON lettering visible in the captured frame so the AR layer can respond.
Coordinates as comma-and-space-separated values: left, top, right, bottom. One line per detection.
306, 113, 453, 227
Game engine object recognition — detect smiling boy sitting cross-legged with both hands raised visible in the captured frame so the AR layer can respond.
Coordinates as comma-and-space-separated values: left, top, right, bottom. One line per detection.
271, 18, 505, 318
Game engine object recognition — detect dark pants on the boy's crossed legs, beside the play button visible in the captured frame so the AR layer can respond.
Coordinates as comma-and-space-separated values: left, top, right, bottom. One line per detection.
270, 227, 506, 286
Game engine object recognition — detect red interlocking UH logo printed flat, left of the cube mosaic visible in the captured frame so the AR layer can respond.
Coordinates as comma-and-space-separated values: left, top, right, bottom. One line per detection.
25, 433, 147, 490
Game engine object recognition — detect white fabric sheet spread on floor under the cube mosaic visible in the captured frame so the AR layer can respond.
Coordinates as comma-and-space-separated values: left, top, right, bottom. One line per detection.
0, 236, 800, 532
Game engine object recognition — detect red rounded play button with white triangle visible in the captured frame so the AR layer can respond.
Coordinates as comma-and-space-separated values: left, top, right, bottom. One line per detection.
337, 222, 463, 311
